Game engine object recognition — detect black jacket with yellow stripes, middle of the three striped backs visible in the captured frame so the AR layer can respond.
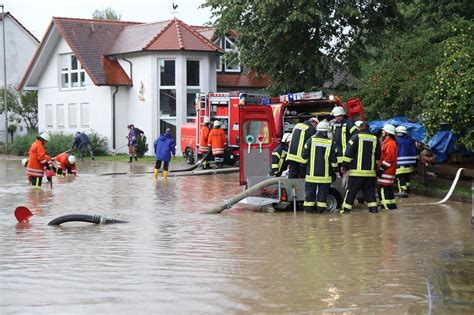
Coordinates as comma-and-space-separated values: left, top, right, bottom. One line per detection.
303, 136, 337, 184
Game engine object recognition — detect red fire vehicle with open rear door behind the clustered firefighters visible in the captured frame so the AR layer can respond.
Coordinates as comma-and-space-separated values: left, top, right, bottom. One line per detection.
239, 91, 364, 210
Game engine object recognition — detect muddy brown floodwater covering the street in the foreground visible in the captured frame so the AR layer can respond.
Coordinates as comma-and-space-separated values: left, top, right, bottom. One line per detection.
0, 157, 474, 314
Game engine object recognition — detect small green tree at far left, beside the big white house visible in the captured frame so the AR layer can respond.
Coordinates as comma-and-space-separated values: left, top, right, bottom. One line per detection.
0, 87, 38, 133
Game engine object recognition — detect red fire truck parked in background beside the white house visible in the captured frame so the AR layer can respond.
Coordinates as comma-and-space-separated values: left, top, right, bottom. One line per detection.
181, 91, 265, 165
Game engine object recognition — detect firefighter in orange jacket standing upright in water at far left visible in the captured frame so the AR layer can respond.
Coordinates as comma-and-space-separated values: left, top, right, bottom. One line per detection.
26, 132, 51, 189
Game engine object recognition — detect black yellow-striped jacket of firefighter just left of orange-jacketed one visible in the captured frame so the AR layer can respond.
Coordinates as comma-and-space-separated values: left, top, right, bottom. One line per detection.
342, 130, 380, 177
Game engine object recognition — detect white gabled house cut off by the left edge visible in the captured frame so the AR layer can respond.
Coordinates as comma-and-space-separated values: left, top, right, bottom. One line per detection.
0, 12, 39, 141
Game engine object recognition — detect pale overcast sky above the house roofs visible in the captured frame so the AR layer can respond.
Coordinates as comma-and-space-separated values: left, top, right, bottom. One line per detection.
0, 0, 211, 40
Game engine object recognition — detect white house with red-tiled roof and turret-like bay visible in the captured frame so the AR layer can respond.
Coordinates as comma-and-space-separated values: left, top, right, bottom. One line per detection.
18, 18, 265, 154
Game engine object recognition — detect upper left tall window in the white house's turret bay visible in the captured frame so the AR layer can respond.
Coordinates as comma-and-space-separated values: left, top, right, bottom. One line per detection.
158, 59, 176, 117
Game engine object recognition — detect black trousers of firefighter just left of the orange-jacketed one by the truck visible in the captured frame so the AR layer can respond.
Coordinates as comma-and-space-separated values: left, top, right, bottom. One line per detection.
341, 176, 378, 213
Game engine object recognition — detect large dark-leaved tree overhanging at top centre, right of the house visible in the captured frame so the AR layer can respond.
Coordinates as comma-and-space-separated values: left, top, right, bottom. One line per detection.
203, 0, 398, 93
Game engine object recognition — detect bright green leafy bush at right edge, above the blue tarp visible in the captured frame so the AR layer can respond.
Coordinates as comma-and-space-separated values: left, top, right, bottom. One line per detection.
423, 20, 474, 151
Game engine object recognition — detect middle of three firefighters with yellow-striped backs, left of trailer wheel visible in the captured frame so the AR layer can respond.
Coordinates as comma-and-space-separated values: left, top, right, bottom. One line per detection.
302, 121, 337, 213
